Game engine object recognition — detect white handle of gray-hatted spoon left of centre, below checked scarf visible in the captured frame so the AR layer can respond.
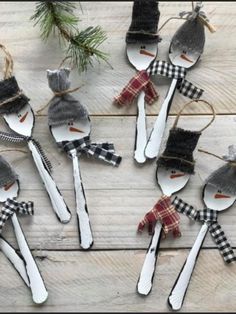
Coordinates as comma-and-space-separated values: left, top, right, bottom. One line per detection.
70, 150, 93, 250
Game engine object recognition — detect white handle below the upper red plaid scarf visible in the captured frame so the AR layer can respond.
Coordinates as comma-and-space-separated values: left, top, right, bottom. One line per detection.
134, 91, 147, 163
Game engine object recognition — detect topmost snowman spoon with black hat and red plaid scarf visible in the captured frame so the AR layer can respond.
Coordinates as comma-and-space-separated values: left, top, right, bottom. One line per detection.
115, 0, 160, 163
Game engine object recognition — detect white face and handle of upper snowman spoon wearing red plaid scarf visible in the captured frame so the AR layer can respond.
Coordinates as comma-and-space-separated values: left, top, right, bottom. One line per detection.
126, 43, 158, 163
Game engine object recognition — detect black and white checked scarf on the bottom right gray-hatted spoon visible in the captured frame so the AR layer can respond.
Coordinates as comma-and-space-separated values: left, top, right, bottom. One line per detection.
172, 196, 236, 264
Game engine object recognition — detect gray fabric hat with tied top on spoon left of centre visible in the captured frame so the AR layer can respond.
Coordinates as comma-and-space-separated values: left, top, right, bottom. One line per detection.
47, 68, 88, 126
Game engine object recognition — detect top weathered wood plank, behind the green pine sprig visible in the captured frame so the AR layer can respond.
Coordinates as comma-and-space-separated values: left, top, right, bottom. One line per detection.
0, 1, 236, 115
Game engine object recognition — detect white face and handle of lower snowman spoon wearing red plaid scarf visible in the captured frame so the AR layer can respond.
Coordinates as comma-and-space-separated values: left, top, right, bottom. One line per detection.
137, 166, 190, 295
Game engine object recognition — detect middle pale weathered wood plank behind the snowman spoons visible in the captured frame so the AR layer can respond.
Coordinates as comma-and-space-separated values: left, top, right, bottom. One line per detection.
0, 116, 236, 249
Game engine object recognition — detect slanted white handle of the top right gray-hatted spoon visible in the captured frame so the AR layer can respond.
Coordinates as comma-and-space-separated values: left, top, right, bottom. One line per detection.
145, 79, 178, 158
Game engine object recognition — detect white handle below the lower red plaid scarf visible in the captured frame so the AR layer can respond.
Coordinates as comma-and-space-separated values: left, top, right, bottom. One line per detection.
137, 222, 162, 295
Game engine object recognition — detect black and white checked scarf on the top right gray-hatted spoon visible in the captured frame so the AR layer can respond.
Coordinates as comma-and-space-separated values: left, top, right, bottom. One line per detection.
147, 60, 204, 99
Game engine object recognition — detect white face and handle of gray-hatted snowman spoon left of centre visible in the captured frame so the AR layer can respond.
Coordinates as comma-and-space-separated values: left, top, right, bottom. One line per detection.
50, 117, 93, 250
